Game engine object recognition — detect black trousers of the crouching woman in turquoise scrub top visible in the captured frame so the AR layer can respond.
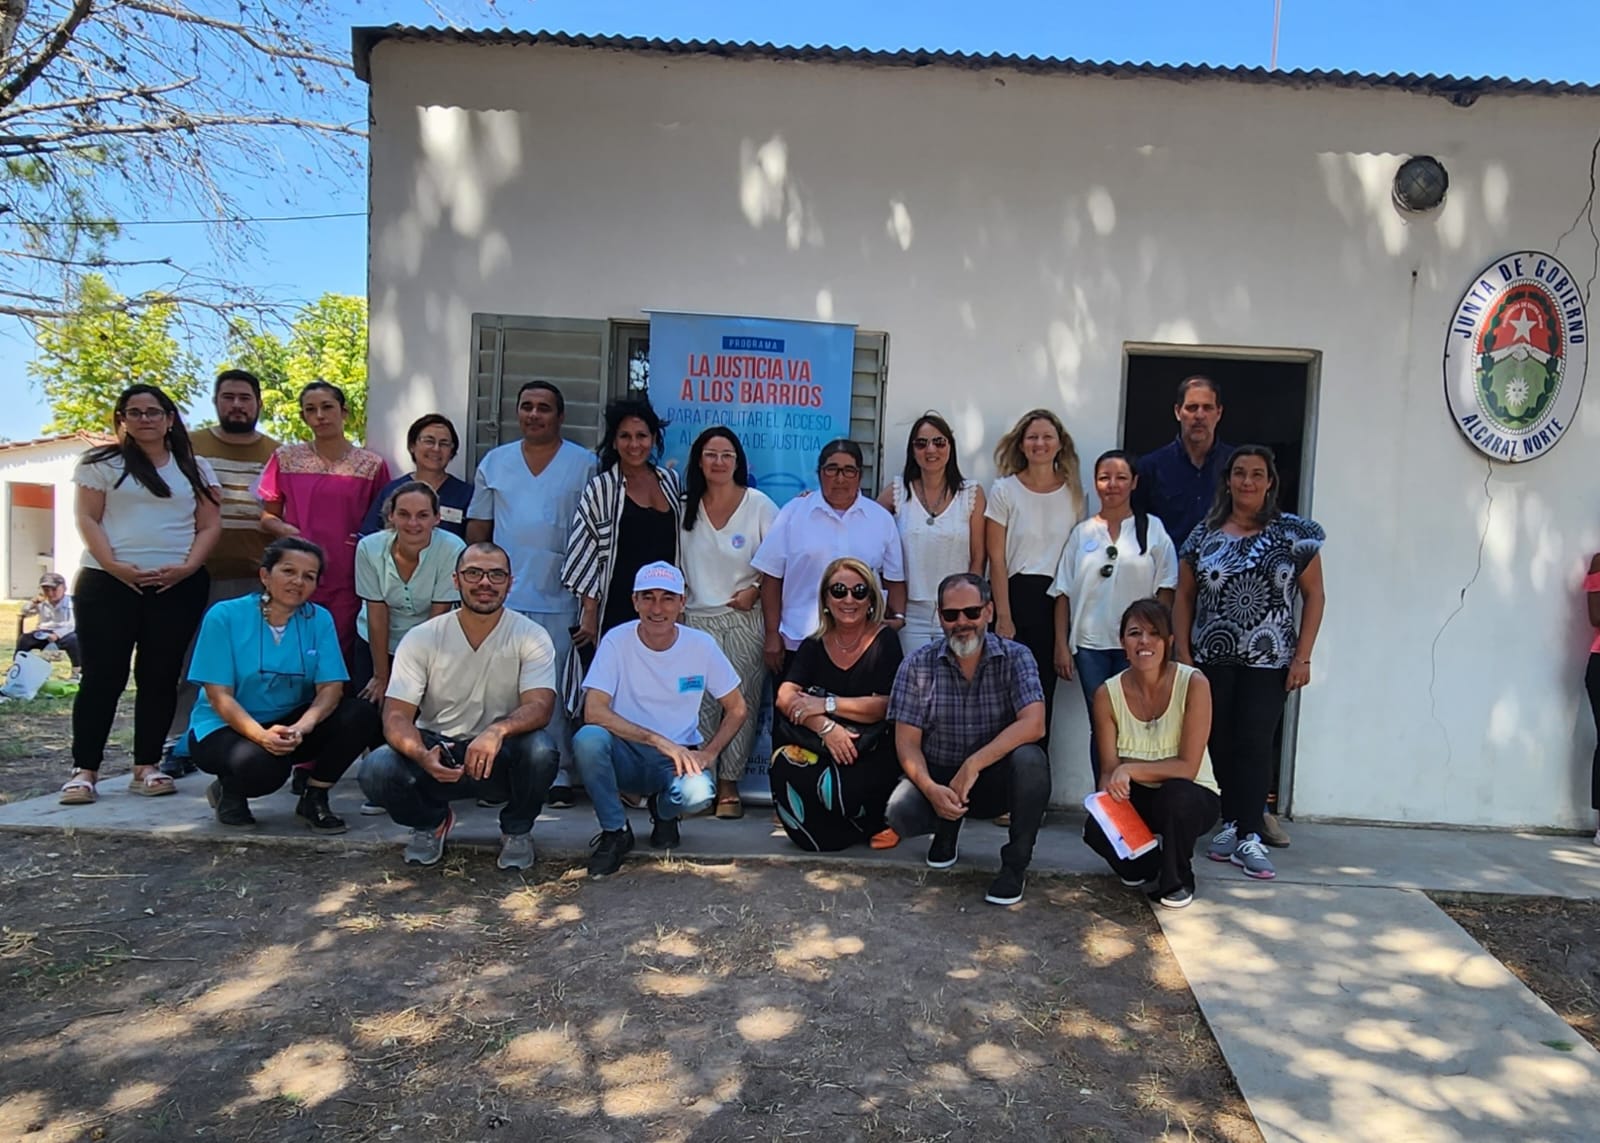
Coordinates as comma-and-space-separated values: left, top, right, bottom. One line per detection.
190, 698, 381, 797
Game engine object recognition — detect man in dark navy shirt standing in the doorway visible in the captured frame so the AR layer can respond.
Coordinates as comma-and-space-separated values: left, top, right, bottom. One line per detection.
1133, 373, 1234, 549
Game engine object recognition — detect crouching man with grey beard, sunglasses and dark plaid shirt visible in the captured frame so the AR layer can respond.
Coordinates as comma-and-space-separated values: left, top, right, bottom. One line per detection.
886, 572, 1050, 904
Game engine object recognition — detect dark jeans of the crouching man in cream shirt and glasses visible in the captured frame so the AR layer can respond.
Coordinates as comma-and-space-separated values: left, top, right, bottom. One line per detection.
360, 726, 555, 837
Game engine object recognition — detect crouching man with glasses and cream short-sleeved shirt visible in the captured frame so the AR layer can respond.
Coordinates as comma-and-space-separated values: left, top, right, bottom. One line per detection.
362, 543, 557, 869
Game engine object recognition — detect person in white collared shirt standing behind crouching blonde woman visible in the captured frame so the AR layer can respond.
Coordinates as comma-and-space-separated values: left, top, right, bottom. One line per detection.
754, 437, 906, 676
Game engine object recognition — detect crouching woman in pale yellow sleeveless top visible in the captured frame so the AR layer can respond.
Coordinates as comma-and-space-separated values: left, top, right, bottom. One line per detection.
1083, 599, 1222, 909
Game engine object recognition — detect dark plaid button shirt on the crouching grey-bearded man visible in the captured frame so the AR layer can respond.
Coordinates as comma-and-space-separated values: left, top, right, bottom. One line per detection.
888, 634, 1045, 770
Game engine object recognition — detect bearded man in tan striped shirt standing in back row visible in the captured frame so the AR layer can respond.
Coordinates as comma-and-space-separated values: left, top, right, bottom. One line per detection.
162, 370, 278, 778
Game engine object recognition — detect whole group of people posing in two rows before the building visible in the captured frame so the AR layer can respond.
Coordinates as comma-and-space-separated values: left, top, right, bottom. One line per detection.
43, 370, 1323, 904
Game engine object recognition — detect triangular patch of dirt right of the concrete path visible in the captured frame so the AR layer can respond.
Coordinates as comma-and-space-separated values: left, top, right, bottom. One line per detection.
1432, 893, 1600, 1049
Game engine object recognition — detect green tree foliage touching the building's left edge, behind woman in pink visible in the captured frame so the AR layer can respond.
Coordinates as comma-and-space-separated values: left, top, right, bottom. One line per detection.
218, 293, 366, 440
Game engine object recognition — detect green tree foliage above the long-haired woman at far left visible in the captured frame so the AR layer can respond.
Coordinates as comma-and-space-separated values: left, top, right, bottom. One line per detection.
27, 274, 205, 432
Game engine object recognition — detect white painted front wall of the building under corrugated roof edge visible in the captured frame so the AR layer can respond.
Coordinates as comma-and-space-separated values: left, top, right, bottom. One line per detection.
370, 42, 1600, 826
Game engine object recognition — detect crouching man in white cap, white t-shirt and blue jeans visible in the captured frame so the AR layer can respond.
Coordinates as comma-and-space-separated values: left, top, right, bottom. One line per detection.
573, 560, 746, 877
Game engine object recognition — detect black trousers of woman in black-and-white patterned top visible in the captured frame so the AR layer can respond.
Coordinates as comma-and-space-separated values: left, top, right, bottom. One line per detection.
1200, 663, 1290, 837
